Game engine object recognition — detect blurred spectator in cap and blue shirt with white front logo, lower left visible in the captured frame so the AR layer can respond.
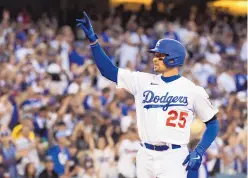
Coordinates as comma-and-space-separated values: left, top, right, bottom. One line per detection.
48, 131, 71, 176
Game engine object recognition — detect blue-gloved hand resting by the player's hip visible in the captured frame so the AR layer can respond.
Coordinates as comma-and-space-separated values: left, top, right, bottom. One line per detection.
183, 150, 202, 171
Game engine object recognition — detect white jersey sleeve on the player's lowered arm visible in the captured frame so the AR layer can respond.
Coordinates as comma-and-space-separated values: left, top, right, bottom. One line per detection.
194, 86, 218, 122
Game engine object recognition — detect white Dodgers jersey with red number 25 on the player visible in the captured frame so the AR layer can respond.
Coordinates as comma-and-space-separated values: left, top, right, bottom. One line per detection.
117, 68, 218, 145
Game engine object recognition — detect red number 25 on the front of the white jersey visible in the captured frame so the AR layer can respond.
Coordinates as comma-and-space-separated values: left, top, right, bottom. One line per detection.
166, 110, 188, 128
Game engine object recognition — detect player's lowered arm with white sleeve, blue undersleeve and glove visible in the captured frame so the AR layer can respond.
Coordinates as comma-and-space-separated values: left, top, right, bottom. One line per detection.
183, 87, 220, 170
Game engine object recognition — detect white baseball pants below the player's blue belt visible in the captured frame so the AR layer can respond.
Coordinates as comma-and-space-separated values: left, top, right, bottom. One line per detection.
136, 145, 189, 178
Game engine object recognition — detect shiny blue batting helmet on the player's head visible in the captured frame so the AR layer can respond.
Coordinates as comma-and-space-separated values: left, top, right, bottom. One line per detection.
149, 38, 186, 67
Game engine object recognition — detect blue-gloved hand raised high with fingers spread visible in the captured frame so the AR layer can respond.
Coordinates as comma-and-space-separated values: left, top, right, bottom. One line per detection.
76, 12, 98, 43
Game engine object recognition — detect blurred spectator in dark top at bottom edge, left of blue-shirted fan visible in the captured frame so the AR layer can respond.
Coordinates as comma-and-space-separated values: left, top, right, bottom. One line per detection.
39, 156, 59, 178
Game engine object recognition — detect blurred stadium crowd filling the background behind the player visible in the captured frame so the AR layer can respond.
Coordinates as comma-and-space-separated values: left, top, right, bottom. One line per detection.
0, 0, 247, 178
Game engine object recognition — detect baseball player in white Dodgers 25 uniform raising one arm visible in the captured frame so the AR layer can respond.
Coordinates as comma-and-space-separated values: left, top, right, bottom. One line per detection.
76, 12, 219, 178
